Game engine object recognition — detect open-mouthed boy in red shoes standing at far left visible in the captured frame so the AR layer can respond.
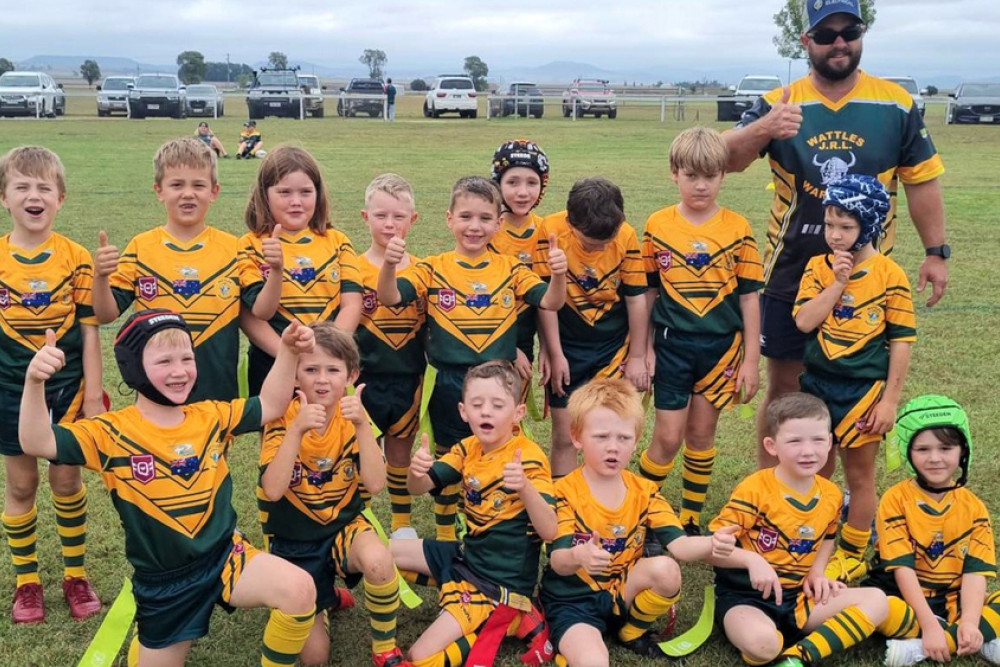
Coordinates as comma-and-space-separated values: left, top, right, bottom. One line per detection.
0, 146, 105, 623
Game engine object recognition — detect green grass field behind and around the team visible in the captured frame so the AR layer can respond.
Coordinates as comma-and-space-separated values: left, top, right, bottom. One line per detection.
0, 90, 1000, 667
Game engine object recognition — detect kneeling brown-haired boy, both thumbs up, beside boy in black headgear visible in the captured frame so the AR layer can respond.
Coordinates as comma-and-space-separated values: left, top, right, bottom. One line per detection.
257, 322, 409, 667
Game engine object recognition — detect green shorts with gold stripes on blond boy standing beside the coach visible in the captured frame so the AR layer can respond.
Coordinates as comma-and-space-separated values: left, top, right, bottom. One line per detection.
653, 327, 743, 410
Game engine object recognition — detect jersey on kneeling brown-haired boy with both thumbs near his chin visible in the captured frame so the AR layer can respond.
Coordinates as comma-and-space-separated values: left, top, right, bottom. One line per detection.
257, 401, 364, 541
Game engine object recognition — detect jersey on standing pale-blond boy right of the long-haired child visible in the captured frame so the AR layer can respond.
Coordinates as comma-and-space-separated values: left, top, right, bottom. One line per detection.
357, 254, 427, 375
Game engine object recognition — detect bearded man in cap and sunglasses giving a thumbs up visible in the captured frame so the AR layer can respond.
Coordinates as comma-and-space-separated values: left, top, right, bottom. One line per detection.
724, 0, 951, 467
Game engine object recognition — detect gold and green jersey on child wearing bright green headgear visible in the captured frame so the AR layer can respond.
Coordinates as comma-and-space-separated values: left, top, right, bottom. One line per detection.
875, 479, 997, 598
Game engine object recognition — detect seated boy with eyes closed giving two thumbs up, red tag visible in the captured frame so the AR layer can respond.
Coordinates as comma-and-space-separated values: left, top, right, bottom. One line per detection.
390, 361, 556, 667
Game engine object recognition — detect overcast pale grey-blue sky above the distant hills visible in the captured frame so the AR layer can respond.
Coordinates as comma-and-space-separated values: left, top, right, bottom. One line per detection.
0, 0, 1000, 82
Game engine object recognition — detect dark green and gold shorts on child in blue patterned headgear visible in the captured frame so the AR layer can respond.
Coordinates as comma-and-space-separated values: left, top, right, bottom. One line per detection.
799, 371, 885, 449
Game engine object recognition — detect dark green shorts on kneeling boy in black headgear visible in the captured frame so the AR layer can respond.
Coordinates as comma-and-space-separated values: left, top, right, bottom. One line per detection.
132, 531, 259, 649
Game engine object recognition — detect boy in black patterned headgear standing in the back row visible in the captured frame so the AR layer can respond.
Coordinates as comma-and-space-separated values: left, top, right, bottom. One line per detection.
490, 139, 549, 402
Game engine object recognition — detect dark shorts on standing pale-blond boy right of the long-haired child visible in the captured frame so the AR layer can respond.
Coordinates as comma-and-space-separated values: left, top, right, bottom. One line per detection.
355, 373, 424, 439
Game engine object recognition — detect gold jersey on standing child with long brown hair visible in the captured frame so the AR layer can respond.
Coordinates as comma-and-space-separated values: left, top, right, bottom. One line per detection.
239, 227, 363, 334
